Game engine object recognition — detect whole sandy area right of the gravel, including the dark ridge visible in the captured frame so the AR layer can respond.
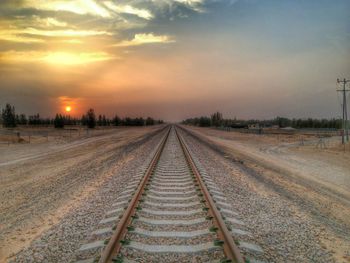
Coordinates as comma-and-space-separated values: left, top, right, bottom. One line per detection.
186, 126, 350, 262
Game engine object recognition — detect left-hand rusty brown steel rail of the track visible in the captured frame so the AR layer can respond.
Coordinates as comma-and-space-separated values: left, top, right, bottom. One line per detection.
98, 128, 171, 263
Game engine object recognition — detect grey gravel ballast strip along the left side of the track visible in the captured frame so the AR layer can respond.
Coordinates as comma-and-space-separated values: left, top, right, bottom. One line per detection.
10, 127, 168, 262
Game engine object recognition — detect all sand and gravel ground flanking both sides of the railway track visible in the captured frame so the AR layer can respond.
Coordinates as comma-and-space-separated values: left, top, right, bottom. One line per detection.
0, 126, 350, 263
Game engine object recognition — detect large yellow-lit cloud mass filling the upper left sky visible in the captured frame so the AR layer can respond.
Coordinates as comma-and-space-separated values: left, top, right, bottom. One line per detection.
0, 0, 198, 65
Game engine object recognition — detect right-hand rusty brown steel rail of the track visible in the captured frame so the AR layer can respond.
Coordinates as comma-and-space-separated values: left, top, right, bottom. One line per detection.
175, 128, 245, 263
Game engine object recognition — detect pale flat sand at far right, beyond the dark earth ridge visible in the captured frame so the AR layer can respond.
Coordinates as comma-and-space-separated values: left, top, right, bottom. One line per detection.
186, 128, 350, 197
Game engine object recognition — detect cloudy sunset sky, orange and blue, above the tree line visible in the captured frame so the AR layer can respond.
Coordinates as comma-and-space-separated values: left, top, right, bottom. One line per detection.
0, 0, 350, 121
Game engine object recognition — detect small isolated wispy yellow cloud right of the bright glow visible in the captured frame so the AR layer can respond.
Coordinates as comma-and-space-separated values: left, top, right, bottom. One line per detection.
113, 33, 175, 47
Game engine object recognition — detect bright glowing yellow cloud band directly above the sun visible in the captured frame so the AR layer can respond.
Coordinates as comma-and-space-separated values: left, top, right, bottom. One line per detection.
0, 51, 117, 65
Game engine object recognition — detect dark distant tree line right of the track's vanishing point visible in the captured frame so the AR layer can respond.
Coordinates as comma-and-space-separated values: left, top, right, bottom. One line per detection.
182, 112, 342, 129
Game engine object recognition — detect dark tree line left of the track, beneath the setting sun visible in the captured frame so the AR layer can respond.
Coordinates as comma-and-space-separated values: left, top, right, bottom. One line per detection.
0, 104, 163, 128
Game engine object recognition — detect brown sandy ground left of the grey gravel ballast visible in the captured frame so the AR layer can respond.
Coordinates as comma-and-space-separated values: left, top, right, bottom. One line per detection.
0, 126, 164, 262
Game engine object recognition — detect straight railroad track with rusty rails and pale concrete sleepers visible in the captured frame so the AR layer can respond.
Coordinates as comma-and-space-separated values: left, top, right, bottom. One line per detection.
76, 126, 262, 263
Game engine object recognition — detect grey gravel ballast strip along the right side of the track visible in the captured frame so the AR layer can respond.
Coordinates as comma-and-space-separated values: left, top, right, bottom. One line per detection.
181, 127, 335, 263
